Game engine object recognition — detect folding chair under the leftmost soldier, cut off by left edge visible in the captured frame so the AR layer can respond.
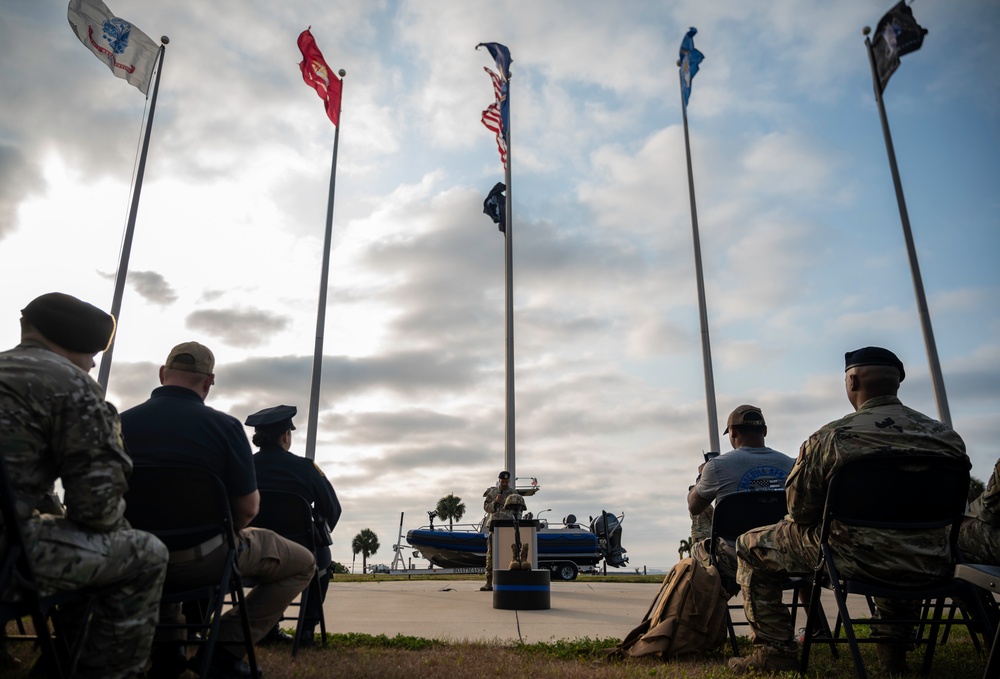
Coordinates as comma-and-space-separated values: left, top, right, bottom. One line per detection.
0, 455, 96, 679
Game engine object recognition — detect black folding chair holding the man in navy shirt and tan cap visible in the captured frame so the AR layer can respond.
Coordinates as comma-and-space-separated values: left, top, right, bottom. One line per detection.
125, 464, 260, 679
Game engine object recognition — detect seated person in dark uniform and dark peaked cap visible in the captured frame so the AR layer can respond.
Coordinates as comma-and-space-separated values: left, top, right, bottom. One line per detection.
244, 405, 341, 646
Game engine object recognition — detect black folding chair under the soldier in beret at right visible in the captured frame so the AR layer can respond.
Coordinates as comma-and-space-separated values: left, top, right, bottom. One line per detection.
801, 453, 985, 679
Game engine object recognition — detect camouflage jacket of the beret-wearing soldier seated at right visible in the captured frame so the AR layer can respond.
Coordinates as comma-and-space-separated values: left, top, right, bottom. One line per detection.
785, 396, 971, 579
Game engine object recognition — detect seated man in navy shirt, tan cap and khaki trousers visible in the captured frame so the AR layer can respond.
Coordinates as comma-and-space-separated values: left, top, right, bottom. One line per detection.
122, 342, 316, 677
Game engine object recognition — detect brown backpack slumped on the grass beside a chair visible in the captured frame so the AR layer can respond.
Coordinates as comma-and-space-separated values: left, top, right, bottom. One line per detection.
614, 557, 729, 660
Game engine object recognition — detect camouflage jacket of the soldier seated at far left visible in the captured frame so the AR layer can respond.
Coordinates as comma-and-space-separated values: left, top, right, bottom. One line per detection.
0, 341, 132, 533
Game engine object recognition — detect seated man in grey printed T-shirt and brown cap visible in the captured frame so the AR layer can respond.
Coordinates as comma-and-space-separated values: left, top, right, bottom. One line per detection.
688, 405, 795, 594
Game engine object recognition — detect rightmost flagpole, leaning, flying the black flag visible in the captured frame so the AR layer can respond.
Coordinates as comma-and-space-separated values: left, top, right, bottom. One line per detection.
862, 31, 951, 427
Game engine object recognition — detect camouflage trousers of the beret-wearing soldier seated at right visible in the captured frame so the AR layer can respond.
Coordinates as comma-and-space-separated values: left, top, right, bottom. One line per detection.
736, 521, 920, 653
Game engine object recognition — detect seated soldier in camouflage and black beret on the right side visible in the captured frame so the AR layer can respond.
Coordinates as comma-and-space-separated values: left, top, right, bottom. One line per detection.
729, 347, 971, 674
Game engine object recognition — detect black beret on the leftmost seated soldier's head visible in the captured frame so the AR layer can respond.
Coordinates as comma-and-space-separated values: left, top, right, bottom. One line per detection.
21, 292, 115, 354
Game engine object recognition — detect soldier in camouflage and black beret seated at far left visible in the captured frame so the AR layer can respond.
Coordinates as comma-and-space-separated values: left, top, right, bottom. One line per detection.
0, 293, 167, 678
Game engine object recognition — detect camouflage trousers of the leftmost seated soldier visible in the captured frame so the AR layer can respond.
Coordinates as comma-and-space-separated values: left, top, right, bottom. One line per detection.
26, 515, 167, 679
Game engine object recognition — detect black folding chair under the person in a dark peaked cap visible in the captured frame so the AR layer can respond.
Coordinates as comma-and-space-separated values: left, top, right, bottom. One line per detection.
250, 489, 326, 657
